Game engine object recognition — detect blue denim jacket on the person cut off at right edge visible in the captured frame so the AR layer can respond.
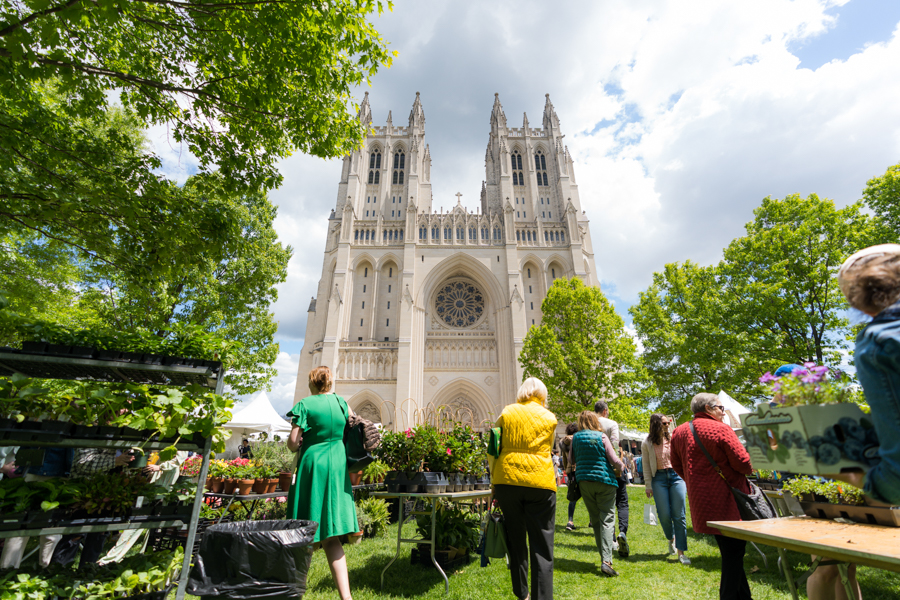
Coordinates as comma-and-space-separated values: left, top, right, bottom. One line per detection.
854, 302, 900, 504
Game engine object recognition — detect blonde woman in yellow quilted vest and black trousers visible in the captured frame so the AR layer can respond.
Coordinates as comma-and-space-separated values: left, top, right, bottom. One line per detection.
491, 377, 556, 600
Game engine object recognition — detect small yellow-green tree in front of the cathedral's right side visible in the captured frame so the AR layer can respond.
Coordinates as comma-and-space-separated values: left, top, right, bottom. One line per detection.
519, 277, 648, 427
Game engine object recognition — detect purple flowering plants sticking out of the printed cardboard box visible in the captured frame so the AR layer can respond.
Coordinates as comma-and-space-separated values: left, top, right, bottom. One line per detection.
759, 362, 854, 406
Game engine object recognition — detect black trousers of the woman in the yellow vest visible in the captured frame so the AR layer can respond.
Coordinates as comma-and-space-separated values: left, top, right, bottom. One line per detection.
494, 484, 556, 600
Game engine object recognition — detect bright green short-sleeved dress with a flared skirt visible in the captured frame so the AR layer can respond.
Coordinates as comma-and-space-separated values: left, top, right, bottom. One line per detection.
287, 394, 359, 542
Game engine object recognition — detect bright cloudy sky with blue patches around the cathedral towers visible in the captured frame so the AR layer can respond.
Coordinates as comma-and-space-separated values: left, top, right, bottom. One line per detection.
154, 0, 900, 412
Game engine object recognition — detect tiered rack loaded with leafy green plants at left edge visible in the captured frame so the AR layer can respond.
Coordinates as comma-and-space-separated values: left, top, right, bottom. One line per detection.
0, 314, 233, 598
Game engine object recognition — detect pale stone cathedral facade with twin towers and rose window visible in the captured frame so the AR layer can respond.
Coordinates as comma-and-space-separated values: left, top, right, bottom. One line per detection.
295, 92, 599, 429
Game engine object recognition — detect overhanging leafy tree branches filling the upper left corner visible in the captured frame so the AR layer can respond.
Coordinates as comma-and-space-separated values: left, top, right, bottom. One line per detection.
0, 0, 392, 282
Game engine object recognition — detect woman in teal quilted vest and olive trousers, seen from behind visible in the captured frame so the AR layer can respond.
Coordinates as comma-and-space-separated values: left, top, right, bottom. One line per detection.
569, 410, 625, 577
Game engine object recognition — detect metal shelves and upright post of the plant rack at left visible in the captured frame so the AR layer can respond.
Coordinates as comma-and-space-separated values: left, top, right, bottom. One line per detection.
0, 351, 225, 600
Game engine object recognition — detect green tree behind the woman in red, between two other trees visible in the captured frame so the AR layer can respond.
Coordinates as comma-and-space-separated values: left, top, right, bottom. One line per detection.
629, 261, 762, 415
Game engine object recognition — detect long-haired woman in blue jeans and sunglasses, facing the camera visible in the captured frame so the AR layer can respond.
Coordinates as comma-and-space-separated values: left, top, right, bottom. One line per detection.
641, 413, 691, 565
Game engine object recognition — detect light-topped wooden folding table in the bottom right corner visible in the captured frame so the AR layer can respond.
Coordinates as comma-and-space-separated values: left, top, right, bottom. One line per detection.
708, 517, 900, 600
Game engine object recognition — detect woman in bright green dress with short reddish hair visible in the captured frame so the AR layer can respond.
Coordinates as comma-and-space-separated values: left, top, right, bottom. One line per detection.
287, 367, 359, 600
